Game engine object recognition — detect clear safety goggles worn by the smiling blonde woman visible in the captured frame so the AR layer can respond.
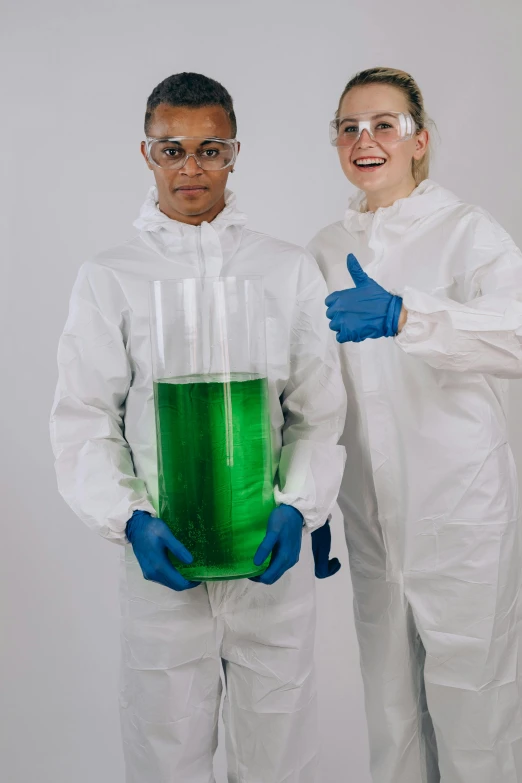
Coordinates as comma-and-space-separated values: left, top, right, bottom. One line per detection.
330, 111, 416, 147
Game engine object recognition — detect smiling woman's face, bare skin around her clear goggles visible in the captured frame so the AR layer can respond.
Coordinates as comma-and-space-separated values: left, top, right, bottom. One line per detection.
337, 84, 429, 197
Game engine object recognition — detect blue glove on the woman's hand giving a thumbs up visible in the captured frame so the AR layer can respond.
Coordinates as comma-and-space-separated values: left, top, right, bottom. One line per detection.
325, 253, 402, 343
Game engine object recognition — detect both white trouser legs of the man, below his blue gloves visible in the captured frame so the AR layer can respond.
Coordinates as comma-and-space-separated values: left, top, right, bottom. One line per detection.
120, 536, 319, 783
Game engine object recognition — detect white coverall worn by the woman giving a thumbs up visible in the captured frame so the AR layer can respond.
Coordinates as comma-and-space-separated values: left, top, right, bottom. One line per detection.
309, 180, 522, 783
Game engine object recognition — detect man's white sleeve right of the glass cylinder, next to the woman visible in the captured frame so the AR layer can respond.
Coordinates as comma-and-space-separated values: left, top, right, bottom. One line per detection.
275, 255, 346, 529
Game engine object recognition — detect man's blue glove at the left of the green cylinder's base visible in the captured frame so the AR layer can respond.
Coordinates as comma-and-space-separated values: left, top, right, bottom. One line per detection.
125, 511, 200, 592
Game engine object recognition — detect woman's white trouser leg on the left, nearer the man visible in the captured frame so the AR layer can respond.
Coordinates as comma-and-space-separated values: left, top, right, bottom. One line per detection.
352, 568, 440, 783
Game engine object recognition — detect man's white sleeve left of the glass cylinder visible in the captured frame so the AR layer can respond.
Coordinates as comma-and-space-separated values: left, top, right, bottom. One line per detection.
50, 265, 155, 543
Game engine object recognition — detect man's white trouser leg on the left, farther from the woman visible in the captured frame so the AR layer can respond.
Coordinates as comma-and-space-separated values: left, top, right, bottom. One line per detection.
120, 547, 221, 783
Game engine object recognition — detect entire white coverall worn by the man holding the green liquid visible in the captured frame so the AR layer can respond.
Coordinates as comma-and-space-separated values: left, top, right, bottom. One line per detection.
51, 188, 345, 783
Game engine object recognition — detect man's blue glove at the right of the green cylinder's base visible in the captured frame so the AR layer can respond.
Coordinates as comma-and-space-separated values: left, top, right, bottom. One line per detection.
252, 504, 303, 585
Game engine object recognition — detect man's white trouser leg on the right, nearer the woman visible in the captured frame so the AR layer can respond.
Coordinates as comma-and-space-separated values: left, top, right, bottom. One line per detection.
223, 534, 318, 783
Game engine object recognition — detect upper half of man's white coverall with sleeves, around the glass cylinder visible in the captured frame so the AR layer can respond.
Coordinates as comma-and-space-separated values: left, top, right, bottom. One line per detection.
51, 188, 345, 543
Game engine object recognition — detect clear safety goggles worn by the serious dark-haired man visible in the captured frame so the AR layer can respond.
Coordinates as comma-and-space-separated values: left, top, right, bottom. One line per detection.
145, 136, 238, 171
